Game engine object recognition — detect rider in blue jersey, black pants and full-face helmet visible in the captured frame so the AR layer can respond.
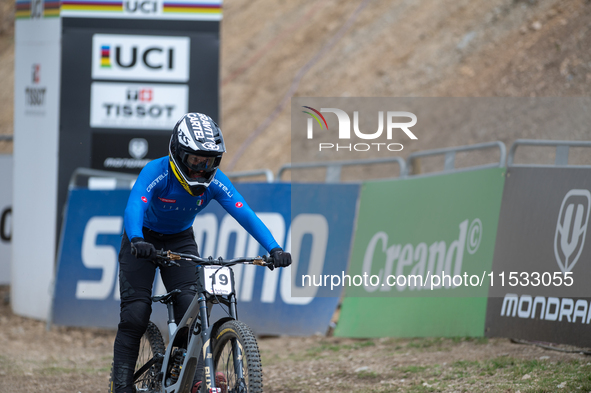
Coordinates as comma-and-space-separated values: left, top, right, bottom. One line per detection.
111, 113, 291, 393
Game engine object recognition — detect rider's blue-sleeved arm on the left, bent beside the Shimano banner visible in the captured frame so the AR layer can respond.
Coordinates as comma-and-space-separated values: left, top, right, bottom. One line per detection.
123, 160, 167, 239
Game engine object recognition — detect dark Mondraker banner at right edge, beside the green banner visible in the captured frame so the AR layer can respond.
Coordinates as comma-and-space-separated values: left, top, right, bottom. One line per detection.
486, 167, 591, 347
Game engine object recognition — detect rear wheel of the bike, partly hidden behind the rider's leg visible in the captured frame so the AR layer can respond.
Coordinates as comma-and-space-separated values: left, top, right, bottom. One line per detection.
109, 321, 166, 393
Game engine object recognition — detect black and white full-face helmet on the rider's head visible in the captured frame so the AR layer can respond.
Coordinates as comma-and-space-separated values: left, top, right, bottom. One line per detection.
169, 113, 226, 196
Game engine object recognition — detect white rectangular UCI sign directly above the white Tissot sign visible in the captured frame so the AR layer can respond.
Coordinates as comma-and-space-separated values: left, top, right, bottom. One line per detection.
92, 34, 190, 82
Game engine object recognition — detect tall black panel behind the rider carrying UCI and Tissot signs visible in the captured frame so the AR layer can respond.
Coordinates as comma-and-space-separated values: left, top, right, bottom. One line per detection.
58, 18, 220, 233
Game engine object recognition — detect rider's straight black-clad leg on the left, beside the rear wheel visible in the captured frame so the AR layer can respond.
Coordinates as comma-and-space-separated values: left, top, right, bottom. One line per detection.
113, 230, 156, 393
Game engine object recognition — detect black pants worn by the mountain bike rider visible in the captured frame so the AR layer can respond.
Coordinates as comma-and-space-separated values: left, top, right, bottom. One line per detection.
113, 228, 199, 393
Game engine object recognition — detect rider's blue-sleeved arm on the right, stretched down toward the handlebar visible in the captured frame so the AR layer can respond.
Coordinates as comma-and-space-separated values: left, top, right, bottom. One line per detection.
209, 169, 280, 251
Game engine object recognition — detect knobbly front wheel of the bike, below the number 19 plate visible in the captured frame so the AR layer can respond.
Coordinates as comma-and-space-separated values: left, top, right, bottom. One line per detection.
213, 321, 263, 393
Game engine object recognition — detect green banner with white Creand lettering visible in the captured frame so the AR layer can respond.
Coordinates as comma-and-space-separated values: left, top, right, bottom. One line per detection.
335, 168, 505, 337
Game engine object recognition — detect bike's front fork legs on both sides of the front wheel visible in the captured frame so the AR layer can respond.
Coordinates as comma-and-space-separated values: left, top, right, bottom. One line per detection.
198, 294, 244, 392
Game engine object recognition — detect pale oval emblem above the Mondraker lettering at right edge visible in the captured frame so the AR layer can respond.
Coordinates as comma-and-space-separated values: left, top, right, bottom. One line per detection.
554, 190, 591, 273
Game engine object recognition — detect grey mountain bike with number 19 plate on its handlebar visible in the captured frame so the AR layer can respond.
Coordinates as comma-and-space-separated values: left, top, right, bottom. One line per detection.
111, 250, 274, 393
